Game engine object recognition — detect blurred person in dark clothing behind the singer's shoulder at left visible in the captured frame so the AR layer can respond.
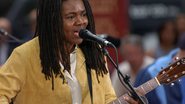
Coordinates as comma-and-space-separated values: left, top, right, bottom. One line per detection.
6, 0, 37, 40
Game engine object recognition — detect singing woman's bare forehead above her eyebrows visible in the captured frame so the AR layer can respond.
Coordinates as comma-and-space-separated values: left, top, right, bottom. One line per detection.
62, 0, 85, 13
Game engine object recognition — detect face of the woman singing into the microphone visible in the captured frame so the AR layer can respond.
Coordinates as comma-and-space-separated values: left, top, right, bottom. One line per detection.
62, 0, 88, 48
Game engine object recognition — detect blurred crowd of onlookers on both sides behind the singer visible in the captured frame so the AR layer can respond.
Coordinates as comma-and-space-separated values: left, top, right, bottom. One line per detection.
0, 0, 185, 104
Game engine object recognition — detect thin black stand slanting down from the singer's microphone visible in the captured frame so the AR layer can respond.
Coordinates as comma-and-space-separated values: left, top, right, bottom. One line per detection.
102, 47, 145, 104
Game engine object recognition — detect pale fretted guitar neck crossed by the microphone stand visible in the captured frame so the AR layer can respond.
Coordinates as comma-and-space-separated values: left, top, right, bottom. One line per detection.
112, 77, 160, 104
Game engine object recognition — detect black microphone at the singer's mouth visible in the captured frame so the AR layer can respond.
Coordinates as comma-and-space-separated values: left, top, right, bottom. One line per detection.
79, 29, 112, 46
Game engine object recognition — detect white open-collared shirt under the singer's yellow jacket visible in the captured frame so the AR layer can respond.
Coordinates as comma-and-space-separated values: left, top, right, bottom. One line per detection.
60, 49, 82, 104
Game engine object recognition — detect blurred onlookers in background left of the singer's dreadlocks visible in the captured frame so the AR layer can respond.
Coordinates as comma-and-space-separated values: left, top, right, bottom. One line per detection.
0, 0, 37, 64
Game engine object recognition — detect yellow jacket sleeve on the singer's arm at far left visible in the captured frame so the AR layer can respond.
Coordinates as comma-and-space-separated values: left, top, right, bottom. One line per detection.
0, 50, 29, 102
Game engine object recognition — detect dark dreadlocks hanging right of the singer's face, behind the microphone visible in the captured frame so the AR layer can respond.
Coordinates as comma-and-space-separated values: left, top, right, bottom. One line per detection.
80, 0, 108, 82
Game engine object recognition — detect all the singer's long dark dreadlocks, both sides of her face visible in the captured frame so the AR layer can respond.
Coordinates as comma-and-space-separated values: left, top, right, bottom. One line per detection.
35, 0, 108, 90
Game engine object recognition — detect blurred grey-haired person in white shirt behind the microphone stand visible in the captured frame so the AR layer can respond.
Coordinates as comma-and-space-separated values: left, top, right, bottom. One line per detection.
111, 35, 154, 97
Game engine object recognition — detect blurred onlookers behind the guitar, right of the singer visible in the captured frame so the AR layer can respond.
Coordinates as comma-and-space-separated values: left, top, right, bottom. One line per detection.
111, 13, 185, 104
